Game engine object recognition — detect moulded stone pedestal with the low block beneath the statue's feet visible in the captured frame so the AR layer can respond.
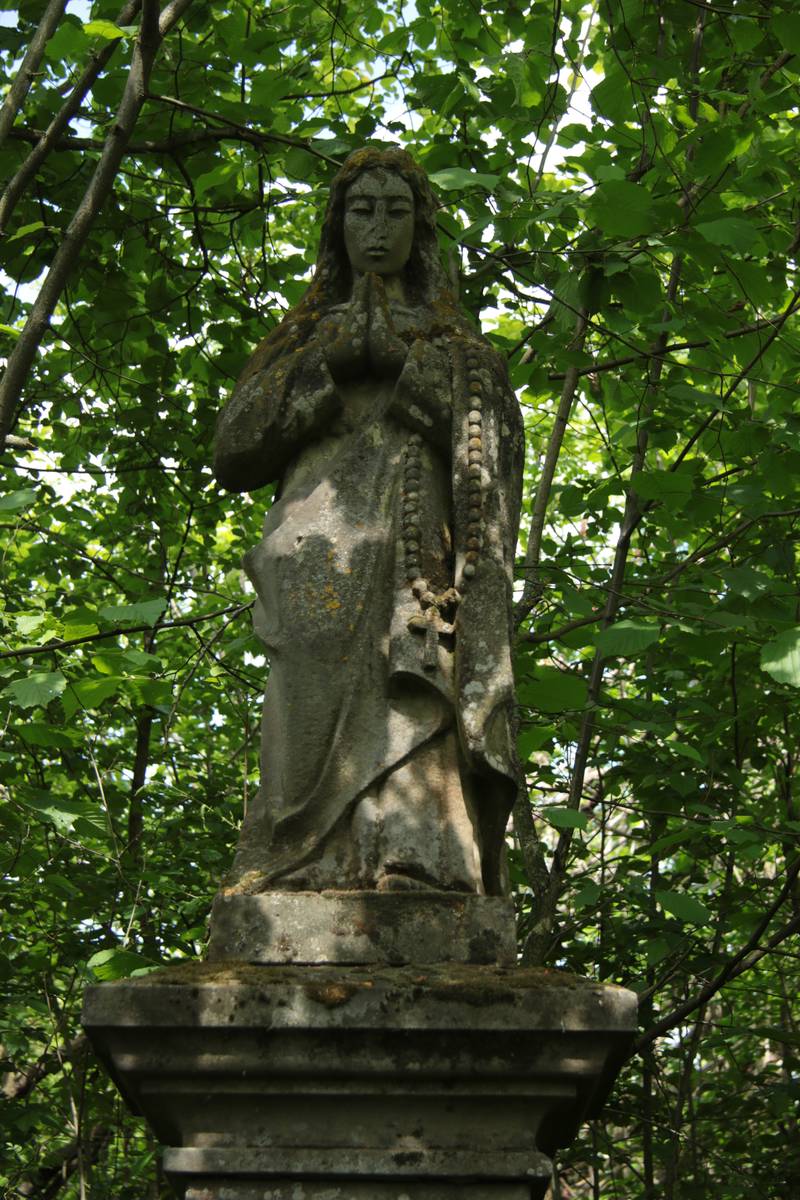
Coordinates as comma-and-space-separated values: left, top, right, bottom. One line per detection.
84, 894, 636, 1200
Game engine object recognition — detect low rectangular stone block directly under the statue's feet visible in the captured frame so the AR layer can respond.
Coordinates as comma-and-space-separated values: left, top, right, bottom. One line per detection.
209, 892, 517, 966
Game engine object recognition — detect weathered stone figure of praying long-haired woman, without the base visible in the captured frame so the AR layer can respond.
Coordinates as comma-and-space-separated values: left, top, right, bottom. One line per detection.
215, 148, 523, 895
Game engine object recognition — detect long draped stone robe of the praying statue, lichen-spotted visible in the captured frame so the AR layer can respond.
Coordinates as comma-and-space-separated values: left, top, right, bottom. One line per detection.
216, 306, 523, 894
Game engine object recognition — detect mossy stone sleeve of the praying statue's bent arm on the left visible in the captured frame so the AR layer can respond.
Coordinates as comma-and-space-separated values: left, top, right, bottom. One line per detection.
213, 343, 341, 492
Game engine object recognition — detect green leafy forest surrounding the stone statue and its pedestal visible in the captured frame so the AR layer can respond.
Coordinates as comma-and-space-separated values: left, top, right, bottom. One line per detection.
0, 0, 800, 1200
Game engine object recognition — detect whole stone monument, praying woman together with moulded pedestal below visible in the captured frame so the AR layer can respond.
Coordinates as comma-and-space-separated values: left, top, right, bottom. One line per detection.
83, 149, 637, 1200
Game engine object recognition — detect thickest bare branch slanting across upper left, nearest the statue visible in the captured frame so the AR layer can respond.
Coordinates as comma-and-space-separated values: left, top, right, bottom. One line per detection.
0, 0, 192, 446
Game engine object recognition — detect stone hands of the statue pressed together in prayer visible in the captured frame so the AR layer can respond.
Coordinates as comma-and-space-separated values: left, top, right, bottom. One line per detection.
325, 271, 408, 380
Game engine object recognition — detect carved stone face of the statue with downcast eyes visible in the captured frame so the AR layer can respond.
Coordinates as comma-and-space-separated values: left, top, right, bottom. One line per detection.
344, 170, 414, 275
